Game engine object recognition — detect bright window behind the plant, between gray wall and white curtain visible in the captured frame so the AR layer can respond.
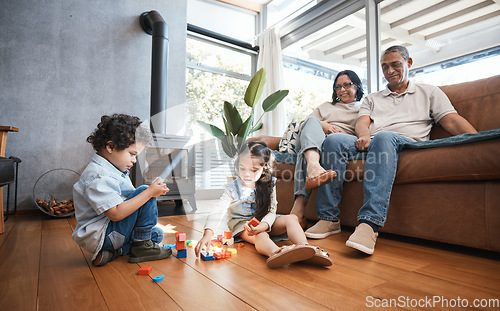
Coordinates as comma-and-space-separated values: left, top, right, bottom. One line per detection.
186, 34, 255, 191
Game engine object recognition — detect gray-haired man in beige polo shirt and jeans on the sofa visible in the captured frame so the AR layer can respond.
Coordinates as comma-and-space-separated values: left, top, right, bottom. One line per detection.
306, 46, 477, 254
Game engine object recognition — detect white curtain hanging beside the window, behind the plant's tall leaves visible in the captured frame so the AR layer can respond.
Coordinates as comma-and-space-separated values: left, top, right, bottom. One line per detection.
254, 28, 287, 136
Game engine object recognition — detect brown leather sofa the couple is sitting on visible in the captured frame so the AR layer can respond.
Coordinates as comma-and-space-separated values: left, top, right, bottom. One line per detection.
252, 75, 500, 252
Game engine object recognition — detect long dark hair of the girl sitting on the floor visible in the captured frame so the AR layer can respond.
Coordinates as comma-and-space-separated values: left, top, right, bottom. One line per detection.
236, 141, 274, 221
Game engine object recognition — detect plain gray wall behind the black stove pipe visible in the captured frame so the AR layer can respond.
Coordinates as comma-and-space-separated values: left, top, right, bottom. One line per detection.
0, 0, 187, 209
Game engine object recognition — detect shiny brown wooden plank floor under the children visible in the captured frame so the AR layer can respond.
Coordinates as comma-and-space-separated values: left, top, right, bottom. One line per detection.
0, 206, 500, 311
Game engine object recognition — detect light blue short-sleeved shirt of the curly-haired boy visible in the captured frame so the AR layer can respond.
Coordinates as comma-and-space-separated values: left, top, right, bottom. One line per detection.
72, 154, 135, 260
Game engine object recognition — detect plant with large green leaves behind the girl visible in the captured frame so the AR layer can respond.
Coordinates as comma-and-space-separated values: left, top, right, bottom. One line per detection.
197, 68, 288, 158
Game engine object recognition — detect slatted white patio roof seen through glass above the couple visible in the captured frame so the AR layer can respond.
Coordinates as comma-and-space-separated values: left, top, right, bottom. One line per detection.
280, 0, 500, 67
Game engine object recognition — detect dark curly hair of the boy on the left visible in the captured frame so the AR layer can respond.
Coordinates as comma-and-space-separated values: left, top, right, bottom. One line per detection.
87, 113, 152, 151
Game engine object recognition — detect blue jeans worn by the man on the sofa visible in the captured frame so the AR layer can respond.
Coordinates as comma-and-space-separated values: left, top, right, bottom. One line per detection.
316, 132, 411, 227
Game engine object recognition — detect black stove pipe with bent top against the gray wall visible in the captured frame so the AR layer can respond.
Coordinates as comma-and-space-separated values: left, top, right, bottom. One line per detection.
139, 11, 168, 134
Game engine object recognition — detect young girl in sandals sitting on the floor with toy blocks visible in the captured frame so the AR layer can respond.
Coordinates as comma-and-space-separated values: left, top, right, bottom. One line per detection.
195, 142, 332, 268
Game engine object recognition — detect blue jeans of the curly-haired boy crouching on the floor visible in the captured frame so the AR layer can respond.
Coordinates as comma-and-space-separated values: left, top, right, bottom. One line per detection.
102, 185, 163, 255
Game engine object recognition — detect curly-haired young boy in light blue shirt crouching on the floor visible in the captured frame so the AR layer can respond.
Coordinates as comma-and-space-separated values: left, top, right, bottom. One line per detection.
72, 114, 172, 266
